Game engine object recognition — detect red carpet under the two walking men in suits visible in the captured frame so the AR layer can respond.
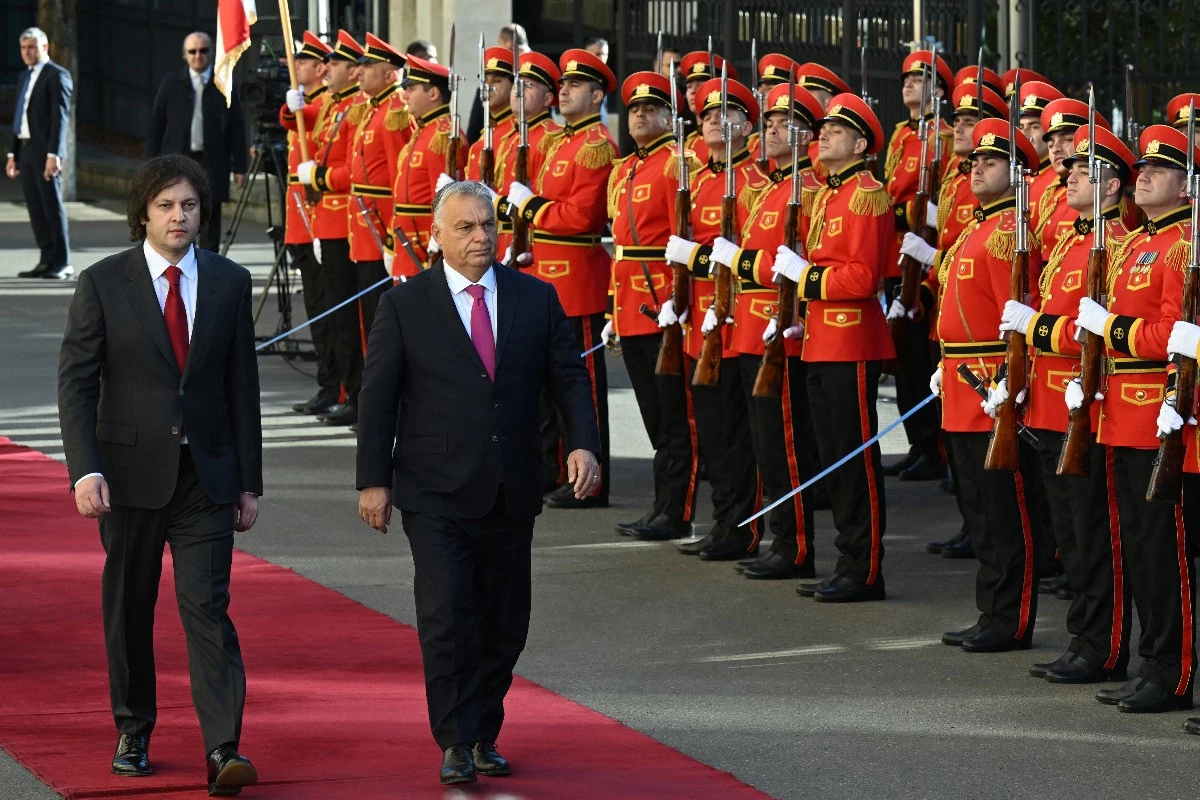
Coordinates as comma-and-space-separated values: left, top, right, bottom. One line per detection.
0, 437, 766, 800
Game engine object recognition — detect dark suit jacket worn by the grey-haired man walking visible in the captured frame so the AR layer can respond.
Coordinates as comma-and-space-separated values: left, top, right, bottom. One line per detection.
358, 263, 600, 519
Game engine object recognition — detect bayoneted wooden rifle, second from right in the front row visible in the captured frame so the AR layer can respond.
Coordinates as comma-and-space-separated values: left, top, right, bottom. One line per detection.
1055, 84, 1109, 477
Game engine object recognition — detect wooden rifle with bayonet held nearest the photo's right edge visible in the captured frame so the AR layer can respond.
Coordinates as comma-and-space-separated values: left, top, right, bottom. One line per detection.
1146, 100, 1200, 504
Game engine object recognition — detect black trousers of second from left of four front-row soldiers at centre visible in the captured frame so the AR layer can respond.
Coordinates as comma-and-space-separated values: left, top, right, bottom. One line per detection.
685, 357, 760, 553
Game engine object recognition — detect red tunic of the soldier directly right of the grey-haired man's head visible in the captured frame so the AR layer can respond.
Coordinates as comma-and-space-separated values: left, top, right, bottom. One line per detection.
518, 114, 617, 317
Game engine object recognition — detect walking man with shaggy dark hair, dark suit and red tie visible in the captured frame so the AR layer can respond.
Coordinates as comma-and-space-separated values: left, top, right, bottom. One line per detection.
59, 155, 263, 795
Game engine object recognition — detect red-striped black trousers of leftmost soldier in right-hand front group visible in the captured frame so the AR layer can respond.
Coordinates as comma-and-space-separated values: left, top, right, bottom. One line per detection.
946, 431, 1039, 640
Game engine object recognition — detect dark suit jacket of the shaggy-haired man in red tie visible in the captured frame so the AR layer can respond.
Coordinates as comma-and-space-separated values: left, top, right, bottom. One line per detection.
59, 243, 263, 509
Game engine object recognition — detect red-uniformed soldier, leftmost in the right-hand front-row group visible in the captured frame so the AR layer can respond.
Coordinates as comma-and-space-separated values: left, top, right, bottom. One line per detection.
930, 115, 1042, 652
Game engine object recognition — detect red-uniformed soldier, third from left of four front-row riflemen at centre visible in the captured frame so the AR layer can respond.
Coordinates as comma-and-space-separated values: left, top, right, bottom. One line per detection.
712, 83, 824, 581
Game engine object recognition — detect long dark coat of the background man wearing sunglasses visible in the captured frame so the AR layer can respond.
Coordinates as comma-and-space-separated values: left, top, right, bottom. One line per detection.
146, 67, 247, 203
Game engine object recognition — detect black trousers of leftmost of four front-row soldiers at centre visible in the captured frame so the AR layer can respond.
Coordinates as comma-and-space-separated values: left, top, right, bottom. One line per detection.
619, 333, 698, 522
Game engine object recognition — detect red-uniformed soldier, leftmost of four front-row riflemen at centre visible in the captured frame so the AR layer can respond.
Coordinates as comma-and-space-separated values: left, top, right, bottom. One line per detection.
601, 72, 701, 540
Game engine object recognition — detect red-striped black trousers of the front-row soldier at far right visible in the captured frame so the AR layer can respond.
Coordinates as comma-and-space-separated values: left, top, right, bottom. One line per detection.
1112, 447, 1196, 694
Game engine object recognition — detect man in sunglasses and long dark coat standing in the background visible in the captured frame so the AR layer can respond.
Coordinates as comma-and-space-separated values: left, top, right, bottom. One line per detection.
146, 31, 246, 252
